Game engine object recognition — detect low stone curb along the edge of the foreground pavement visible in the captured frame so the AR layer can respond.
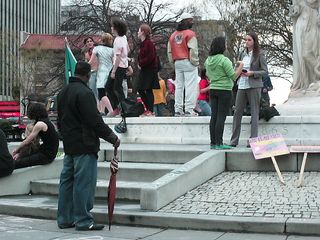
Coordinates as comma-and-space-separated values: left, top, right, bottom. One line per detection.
0, 204, 292, 235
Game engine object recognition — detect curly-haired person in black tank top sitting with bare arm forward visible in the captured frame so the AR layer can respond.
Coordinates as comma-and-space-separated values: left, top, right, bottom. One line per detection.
13, 102, 59, 169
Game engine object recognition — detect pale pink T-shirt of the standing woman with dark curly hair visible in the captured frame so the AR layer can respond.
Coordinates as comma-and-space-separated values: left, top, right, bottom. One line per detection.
113, 36, 129, 68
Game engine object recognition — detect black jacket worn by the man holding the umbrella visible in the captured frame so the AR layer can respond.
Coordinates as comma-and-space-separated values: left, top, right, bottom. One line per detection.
57, 77, 118, 154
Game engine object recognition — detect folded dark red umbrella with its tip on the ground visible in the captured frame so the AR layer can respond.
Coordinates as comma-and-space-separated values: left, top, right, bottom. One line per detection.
108, 147, 118, 231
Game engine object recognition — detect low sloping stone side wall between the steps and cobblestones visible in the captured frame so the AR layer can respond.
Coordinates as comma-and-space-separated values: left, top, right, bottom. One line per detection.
140, 151, 226, 211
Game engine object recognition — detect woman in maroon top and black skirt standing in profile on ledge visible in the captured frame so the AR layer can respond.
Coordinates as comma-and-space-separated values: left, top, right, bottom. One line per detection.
137, 24, 160, 116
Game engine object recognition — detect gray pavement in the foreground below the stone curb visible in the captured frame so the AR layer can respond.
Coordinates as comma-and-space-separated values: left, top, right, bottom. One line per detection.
0, 215, 320, 240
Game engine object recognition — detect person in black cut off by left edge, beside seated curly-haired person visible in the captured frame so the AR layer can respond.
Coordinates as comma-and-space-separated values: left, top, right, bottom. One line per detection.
0, 129, 14, 177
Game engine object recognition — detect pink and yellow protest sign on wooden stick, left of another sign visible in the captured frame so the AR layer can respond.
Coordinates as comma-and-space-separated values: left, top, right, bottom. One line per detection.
249, 133, 289, 184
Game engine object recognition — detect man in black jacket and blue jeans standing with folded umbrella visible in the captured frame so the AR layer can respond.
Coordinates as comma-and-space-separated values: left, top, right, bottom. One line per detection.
57, 62, 120, 230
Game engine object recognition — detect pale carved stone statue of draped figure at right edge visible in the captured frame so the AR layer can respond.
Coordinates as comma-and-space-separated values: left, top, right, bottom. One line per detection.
291, 0, 320, 91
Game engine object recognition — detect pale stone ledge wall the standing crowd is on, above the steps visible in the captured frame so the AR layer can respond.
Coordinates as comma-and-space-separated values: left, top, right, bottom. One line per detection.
104, 115, 320, 146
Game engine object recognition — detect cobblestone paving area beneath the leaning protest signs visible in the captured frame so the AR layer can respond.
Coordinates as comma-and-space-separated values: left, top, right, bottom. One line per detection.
159, 172, 320, 219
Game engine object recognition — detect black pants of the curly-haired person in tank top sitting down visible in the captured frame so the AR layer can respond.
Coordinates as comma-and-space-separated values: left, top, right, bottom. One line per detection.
14, 152, 54, 169
